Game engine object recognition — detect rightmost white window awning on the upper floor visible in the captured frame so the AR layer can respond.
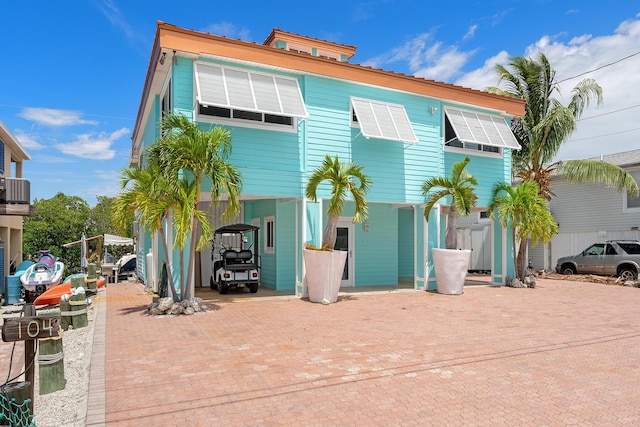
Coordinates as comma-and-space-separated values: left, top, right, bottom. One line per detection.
444, 107, 520, 150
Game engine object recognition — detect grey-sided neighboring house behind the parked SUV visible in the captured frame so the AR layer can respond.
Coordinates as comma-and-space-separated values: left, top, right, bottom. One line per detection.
529, 150, 640, 270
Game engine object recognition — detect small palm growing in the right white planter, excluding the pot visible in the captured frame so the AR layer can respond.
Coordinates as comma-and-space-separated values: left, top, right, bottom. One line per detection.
422, 157, 478, 249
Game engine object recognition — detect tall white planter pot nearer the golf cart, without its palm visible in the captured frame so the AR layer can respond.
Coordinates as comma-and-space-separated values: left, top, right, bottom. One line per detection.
302, 249, 347, 304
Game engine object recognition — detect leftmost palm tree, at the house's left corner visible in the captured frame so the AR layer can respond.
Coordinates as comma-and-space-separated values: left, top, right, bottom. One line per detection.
112, 164, 177, 301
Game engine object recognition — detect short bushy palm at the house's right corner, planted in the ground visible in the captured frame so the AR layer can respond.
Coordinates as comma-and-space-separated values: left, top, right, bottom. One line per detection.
487, 180, 558, 280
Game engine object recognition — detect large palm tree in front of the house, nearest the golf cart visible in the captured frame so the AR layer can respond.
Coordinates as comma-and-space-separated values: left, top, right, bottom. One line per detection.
150, 114, 242, 299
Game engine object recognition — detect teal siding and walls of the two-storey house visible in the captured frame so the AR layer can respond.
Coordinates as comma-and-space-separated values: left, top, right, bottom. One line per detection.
142, 58, 513, 296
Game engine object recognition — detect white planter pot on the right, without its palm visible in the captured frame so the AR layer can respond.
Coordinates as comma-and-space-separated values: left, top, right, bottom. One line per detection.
431, 248, 471, 295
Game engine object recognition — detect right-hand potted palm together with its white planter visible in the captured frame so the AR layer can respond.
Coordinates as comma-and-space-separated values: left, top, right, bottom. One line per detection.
422, 157, 478, 295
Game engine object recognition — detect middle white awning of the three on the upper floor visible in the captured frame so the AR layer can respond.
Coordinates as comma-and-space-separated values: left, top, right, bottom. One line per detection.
351, 98, 418, 144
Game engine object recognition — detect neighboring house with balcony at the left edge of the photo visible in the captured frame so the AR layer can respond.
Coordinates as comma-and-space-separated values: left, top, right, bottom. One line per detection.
0, 121, 33, 293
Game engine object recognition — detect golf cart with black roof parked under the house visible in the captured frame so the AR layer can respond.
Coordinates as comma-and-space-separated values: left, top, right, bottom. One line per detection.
209, 224, 260, 294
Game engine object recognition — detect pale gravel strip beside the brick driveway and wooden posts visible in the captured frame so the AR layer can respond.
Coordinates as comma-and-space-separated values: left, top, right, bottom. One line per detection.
3, 290, 103, 427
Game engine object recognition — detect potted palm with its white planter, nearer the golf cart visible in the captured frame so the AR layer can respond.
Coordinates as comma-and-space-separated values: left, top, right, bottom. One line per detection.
302, 154, 371, 304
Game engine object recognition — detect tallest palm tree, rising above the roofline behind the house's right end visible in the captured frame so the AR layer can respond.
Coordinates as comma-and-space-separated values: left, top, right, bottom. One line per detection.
487, 53, 638, 200
